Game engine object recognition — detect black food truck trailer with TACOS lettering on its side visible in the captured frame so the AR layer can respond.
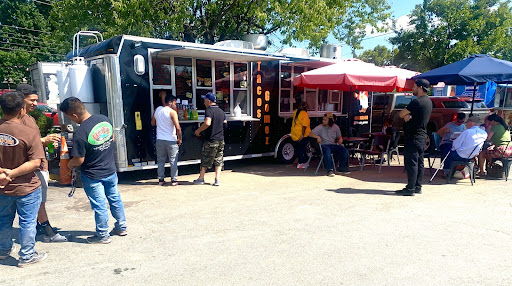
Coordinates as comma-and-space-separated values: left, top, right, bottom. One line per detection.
35, 32, 364, 172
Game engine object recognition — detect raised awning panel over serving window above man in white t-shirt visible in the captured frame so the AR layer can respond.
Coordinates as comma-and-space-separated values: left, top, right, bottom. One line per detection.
153, 46, 288, 62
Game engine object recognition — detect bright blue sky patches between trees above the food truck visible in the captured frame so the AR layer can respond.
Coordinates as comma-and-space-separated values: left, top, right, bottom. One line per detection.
271, 0, 423, 58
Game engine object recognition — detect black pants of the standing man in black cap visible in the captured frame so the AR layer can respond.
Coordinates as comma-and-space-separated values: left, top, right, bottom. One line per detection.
404, 138, 427, 191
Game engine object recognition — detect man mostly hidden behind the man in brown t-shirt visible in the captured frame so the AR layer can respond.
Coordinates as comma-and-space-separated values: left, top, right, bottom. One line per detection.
16, 83, 68, 242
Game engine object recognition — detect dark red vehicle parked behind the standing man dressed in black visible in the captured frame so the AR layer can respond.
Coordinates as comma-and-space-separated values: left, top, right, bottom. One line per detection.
372, 93, 489, 132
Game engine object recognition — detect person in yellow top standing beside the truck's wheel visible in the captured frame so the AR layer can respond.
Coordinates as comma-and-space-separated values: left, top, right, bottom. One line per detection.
290, 101, 311, 169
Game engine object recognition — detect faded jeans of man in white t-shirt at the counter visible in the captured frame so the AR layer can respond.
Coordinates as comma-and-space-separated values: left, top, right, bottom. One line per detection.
156, 139, 180, 181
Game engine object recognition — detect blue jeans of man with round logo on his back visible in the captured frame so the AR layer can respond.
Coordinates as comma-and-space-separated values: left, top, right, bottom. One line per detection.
82, 173, 126, 237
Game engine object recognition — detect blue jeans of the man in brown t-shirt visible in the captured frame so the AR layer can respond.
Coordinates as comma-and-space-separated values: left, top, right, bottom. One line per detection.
0, 187, 41, 260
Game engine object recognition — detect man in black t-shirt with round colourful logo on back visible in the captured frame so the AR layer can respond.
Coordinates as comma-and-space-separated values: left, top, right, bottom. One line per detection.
60, 97, 128, 243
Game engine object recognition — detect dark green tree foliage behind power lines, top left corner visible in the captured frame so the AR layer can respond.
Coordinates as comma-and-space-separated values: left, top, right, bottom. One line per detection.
0, 0, 68, 84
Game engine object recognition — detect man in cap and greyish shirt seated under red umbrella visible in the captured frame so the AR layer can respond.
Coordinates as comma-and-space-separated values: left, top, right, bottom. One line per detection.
309, 112, 350, 177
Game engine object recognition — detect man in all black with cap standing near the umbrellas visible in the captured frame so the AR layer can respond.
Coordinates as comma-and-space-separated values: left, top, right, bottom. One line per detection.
396, 79, 432, 196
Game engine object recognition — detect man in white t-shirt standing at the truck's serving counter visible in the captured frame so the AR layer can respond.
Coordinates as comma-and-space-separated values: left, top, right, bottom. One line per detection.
151, 95, 182, 186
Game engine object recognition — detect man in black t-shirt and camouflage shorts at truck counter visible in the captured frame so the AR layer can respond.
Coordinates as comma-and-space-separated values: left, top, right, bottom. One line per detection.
194, 92, 227, 186
